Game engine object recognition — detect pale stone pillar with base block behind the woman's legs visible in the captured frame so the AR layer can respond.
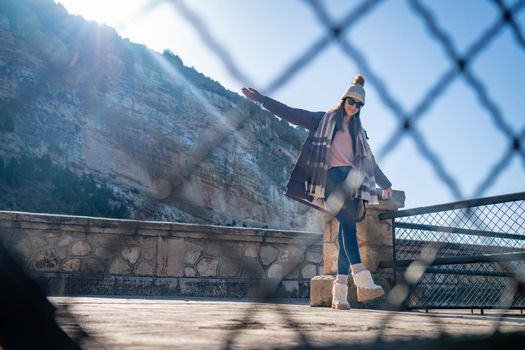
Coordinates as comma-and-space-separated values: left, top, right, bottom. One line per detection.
310, 191, 405, 306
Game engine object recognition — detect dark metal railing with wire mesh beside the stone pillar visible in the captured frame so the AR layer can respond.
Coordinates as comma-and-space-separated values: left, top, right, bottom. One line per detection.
380, 192, 525, 309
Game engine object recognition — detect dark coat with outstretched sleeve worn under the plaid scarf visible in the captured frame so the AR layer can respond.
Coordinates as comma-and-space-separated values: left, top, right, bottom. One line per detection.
262, 97, 392, 211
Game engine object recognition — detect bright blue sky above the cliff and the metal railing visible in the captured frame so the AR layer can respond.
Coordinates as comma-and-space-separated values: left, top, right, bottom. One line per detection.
58, 0, 525, 207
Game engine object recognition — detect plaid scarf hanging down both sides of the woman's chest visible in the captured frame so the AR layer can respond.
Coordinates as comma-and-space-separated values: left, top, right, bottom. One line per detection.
305, 112, 378, 204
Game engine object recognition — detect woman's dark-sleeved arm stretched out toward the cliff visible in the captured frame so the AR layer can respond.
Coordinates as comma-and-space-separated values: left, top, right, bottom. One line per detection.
242, 88, 325, 130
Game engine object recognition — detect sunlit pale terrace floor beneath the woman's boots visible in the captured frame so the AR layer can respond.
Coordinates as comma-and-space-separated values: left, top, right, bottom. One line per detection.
49, 297, 525, 349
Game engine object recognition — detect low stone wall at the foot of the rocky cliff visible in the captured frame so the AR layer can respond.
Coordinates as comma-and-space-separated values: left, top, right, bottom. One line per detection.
0, 211, 323, 297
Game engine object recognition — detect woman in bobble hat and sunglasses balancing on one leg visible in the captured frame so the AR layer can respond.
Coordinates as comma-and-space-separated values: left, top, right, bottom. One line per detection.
242, 74, 392, 310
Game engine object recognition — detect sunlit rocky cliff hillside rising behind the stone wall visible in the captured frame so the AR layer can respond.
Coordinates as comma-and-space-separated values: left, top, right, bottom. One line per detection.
0, 0, 321, 231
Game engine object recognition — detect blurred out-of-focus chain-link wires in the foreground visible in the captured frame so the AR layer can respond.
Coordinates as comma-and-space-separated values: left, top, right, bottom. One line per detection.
152, 0, 525, 348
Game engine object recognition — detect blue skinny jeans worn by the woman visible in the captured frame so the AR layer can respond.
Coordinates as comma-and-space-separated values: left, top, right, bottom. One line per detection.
325, 166, 361, 275
